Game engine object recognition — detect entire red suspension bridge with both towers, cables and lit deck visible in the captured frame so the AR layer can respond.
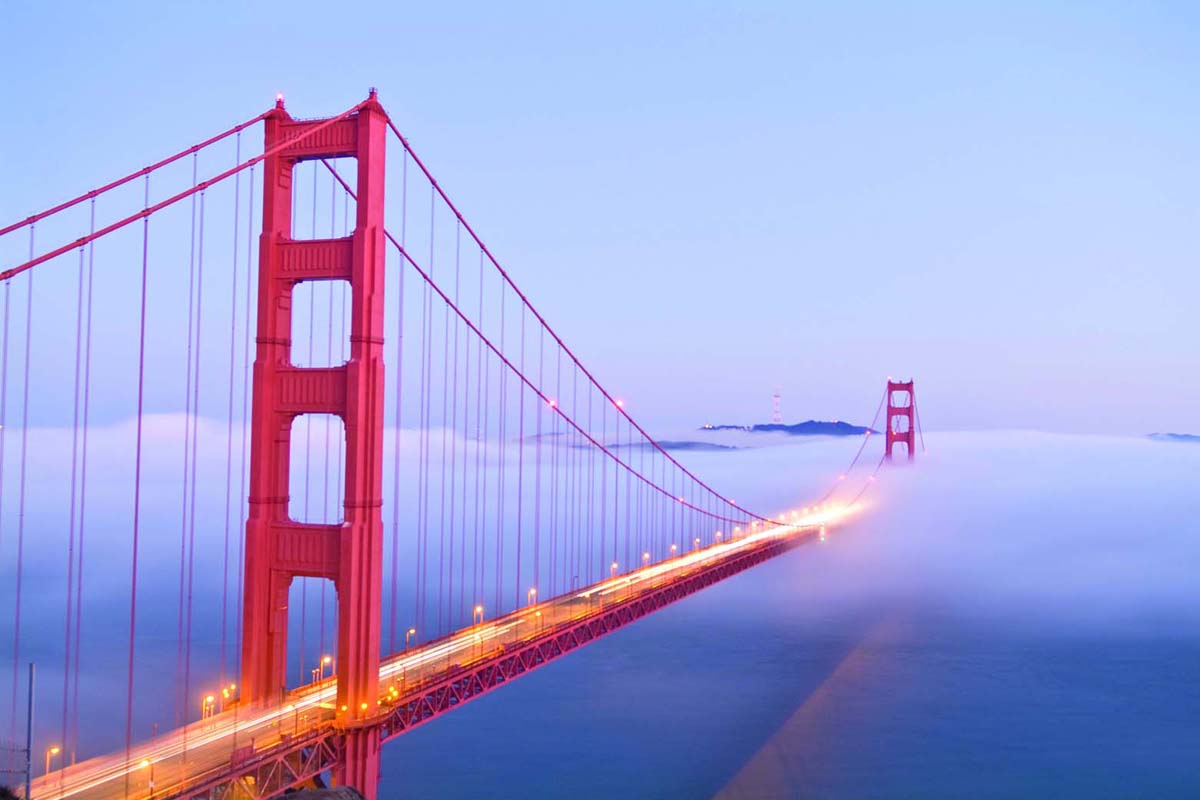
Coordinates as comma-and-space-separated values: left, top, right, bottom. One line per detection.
0, 91, 919, 799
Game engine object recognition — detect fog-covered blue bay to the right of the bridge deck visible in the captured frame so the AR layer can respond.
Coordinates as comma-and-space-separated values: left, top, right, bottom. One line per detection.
382, 434, 1200, 800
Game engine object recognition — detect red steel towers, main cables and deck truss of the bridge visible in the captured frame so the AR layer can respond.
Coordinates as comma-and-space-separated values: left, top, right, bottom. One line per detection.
0, 91, 897, 800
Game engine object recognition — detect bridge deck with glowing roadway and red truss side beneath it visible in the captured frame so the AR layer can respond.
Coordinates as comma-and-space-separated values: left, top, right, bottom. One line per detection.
32, 510, 844, 800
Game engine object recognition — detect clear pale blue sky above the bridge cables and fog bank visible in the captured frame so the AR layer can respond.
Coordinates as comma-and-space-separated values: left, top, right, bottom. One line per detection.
0, 2, 1200, 433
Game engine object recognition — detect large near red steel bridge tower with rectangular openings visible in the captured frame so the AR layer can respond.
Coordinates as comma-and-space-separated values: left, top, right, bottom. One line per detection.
241, 92, 388, 798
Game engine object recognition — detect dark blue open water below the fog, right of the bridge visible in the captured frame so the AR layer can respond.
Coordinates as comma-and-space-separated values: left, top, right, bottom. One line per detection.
383, 548, 1200, 799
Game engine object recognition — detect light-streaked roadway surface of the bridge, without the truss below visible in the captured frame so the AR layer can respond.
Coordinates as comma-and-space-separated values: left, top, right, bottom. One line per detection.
31, 506, 848, 800
